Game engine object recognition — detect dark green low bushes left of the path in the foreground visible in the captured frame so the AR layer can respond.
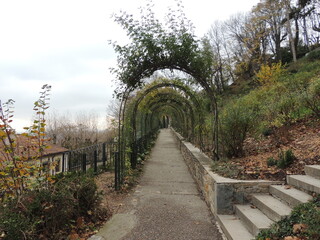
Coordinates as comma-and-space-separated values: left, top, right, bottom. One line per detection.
0, 173, 100, 239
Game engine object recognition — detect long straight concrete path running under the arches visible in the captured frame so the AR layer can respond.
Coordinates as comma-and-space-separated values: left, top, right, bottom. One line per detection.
91, 129, 222, 240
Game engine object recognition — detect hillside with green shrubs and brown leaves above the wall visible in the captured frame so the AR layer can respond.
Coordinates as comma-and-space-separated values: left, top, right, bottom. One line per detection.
213, 54, 320, 180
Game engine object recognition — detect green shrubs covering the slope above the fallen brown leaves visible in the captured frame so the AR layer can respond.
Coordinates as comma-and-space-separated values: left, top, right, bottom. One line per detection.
216, 59, 320, 159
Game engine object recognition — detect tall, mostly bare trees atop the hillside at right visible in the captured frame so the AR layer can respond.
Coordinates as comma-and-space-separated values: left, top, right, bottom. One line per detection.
207, 0, 320, 86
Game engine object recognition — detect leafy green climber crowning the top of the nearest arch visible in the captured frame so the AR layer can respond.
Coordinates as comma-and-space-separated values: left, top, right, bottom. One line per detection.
113, 1, 213, 94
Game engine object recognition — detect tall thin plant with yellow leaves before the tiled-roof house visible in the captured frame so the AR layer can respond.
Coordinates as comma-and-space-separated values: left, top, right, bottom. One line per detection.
0, 85, 51, 200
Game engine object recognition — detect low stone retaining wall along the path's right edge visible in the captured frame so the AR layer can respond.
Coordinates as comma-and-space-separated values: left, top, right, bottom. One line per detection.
172, 130, 282, 214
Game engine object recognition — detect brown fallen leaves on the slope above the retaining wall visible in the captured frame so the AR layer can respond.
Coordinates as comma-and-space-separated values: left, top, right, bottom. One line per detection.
210, 119, 320, 181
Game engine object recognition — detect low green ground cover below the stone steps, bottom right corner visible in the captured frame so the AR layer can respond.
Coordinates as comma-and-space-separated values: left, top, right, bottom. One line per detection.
256, 197, 320, 240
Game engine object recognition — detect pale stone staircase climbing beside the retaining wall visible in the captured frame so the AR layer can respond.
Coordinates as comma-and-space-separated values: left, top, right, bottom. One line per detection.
217, 165, 320, 240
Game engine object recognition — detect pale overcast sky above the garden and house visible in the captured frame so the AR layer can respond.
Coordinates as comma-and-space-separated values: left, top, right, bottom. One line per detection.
0, 0, 258, 130
